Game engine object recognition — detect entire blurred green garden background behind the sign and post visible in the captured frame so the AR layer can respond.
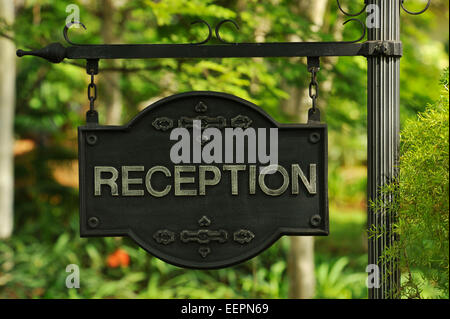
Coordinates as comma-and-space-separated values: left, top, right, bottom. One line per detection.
0, 0, 449, 298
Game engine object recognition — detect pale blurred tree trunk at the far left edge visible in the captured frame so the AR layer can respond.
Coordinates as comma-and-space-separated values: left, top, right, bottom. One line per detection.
0, 0, 16, 238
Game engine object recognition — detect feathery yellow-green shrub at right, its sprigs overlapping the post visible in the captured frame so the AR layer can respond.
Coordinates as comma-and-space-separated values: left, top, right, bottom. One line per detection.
371, 69, 449, 298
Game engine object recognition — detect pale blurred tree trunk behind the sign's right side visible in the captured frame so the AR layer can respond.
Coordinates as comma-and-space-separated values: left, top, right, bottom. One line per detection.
282, 0, 328, 299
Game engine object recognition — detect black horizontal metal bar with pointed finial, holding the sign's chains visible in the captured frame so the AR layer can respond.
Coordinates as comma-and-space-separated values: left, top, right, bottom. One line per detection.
17, 41, 402, 63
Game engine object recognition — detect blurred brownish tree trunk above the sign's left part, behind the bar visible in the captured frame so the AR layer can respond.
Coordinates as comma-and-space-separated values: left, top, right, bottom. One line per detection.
99, 0, 122, 125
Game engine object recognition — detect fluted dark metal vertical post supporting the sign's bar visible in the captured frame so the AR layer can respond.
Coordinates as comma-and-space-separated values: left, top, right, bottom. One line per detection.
367, 0, 400, 299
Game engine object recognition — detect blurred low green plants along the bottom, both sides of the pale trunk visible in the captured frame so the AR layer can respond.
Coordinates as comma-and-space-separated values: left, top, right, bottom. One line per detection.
0, 201, 367, 298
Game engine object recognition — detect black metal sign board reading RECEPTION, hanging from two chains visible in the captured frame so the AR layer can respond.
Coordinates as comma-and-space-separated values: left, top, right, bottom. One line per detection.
79, 92, 328, 269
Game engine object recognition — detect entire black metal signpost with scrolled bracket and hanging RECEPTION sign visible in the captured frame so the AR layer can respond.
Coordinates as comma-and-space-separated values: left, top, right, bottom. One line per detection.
17, 0, 431, 298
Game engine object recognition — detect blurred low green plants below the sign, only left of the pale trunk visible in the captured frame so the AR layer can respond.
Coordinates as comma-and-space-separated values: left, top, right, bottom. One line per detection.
0, 208, 287, 298
